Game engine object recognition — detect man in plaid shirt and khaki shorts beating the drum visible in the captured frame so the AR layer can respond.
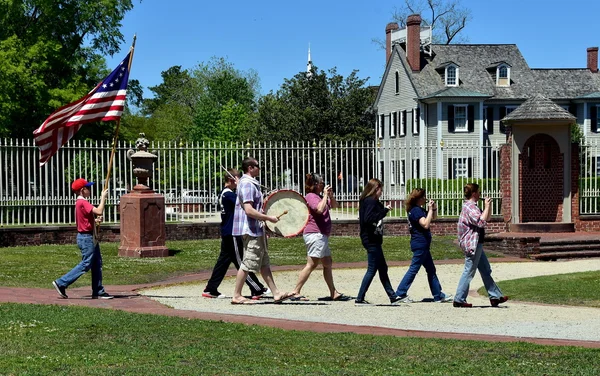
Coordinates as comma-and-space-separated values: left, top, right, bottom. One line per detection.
231, 157, 291, 304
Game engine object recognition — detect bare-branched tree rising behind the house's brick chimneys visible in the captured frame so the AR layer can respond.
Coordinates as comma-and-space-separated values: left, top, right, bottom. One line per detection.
393, 0, 471, 44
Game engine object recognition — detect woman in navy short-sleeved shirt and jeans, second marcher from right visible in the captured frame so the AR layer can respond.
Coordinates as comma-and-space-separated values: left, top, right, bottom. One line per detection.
396, 188, 452, 303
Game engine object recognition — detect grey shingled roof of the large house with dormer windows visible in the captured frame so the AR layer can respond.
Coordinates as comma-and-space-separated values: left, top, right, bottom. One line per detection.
394, 44, 600, 100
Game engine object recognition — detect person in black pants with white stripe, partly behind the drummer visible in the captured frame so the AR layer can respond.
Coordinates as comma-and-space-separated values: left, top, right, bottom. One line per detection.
202, 168, 269, 300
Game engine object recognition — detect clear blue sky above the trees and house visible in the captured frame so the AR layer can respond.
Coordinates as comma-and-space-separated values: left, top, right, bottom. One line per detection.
107, 0, 600, 96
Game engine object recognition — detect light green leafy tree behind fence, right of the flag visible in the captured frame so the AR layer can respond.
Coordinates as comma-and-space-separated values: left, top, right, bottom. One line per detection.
138, 57, 260, 141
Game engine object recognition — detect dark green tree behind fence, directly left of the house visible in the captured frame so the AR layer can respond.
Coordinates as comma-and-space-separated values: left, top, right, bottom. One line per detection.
254, 67, 375, 141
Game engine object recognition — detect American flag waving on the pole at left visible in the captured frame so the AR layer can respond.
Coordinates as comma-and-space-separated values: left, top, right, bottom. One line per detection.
33, 52, 131, 167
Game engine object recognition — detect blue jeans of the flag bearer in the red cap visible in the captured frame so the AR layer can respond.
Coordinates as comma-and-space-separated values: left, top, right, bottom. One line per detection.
56, 234, 105, 296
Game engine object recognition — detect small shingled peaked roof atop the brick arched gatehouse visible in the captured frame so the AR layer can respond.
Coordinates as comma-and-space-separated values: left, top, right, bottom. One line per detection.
501, 94, 576, 123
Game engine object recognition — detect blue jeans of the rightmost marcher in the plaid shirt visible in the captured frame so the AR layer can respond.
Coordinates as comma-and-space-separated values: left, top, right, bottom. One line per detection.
454, 244, 502, 303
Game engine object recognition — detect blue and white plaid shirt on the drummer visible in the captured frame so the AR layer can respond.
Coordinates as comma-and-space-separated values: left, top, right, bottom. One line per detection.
233, 175, 264, 237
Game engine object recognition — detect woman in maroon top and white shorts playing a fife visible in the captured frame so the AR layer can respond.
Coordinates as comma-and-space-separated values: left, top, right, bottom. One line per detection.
291, 174, 351, 301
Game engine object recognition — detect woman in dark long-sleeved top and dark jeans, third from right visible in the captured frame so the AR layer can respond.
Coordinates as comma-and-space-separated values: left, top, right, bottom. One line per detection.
355, 179, 400, 305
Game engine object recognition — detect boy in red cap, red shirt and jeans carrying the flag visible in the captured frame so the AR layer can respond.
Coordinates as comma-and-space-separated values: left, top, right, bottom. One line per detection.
52, 178, 113, 299
